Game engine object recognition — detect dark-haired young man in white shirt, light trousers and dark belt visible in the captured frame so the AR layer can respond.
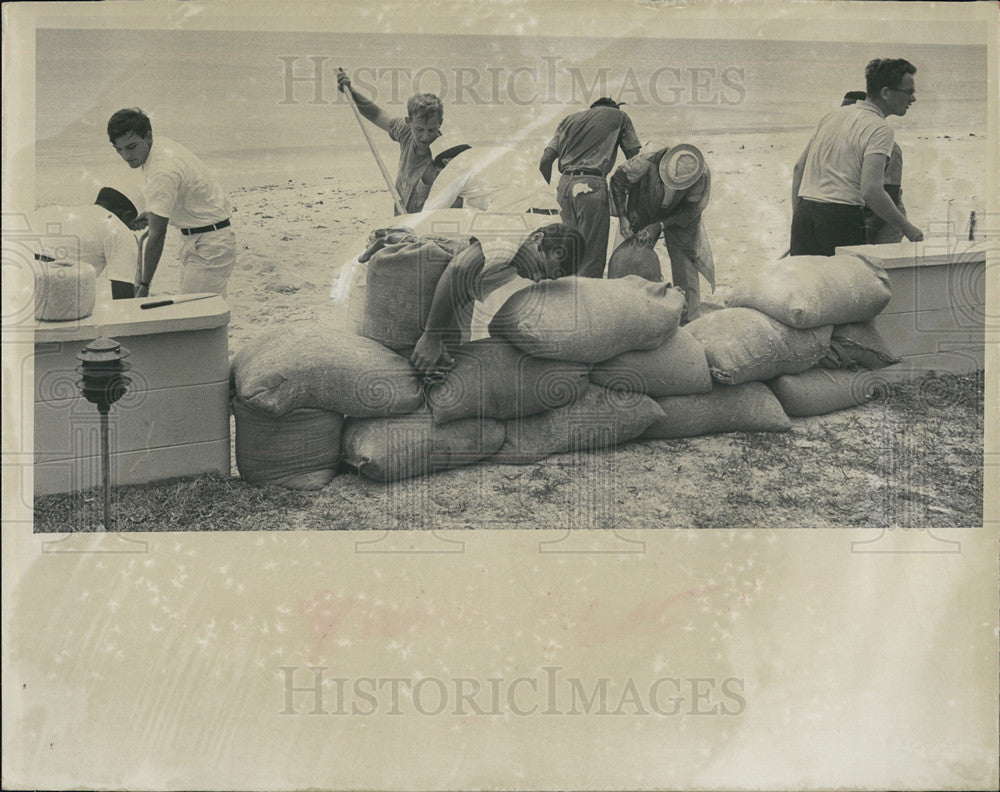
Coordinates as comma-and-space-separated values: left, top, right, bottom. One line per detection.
108, 108, 236, 297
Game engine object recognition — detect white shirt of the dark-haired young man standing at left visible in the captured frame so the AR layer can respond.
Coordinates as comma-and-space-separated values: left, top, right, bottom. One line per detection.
142, 135, 232, 228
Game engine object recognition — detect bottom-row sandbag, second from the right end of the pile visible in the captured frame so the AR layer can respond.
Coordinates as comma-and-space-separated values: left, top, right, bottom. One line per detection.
639, 382, 792, 440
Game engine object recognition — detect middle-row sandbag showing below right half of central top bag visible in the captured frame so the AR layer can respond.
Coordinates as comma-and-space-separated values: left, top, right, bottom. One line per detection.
590, 327, 712, 399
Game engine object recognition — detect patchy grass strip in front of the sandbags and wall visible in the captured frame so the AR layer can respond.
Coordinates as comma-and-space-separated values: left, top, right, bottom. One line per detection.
35, 372, 983, 532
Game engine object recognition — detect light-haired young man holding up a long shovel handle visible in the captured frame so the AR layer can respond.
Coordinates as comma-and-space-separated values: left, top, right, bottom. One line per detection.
337, 69, 444, 215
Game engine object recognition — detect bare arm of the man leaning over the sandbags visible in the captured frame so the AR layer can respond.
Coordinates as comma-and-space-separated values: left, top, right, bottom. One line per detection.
410, 241, 485, 374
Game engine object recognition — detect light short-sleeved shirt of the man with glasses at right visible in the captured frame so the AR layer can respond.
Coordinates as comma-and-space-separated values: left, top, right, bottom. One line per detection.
799, 102, 893, 206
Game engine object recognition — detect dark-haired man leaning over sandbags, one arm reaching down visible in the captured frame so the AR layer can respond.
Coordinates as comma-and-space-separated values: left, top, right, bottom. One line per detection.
410, 223, 585, 374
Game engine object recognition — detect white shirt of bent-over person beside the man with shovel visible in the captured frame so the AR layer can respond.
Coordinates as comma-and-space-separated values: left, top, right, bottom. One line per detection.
424, 146, 559, 213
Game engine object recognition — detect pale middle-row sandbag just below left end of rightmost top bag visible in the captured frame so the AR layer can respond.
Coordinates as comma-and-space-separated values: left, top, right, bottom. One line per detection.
687, 308, 833, 385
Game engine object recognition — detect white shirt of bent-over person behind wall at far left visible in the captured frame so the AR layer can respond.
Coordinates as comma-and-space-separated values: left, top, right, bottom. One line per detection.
32, 204, 139, 283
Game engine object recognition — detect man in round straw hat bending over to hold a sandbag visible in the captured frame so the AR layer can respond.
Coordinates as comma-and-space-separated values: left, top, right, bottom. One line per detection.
611, 143, 715, 322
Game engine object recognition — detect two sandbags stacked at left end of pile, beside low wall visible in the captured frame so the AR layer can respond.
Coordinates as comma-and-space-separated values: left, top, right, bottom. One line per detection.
230, 328, 422, 489
